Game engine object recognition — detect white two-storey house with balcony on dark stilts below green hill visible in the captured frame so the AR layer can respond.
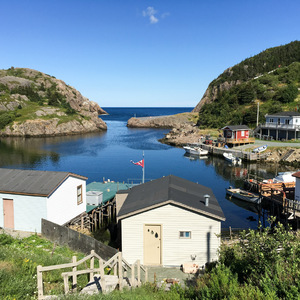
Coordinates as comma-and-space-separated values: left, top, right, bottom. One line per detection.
255, 111, 300, 140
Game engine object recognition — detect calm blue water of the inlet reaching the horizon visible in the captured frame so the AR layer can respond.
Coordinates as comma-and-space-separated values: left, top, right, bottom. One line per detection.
0, 107, 276, 228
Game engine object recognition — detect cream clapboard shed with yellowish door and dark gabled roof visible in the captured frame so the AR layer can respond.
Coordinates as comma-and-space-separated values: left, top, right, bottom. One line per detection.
117, 175, 225, 266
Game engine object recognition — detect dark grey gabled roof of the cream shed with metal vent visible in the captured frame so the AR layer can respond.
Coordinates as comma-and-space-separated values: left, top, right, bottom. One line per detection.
118, 175, 225, 221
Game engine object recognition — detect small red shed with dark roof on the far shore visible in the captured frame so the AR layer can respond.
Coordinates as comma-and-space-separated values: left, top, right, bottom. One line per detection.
222, 125, 254, 145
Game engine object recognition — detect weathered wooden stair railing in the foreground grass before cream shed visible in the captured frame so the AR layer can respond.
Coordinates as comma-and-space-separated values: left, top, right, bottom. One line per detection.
37, 250, 148, 299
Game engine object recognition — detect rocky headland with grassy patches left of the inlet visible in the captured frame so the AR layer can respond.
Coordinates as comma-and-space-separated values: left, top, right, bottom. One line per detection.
0, 67, 107, 136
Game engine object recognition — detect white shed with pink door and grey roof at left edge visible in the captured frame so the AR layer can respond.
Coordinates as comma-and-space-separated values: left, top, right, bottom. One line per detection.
0, 168, 87, 233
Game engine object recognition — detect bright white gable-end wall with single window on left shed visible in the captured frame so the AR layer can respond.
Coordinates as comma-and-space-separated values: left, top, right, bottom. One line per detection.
47, 176, 86, 225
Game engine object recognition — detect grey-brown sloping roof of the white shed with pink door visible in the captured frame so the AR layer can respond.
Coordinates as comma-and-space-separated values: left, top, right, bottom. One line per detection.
0, 168, 87, 196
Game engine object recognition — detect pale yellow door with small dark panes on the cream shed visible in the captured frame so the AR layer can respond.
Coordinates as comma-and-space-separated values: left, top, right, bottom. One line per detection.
144, 225, 161, 265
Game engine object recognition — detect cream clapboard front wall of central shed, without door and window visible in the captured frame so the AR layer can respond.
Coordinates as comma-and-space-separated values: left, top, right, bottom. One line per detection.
121, 205, 221, 266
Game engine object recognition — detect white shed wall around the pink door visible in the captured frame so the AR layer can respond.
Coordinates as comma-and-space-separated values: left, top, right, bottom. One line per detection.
0, 194, 47, 233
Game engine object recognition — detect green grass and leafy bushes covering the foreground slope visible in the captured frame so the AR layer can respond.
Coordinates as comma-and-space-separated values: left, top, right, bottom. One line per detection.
0, 220, 300, 300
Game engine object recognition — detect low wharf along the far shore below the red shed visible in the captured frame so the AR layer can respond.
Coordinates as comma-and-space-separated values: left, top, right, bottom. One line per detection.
199, 144, 268, 161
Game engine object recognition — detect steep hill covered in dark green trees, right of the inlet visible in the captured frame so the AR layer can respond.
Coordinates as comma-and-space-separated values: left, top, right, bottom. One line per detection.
193, 41, 300, 128
